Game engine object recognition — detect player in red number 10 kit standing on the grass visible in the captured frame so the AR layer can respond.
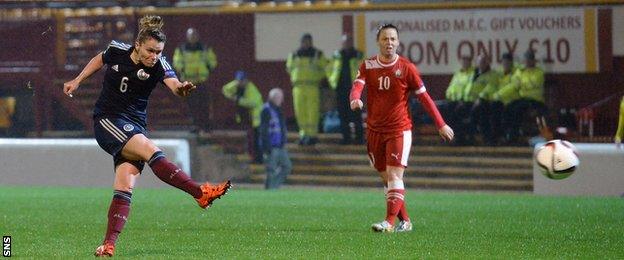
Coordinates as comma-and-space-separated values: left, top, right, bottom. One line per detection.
350, 24, 453, 232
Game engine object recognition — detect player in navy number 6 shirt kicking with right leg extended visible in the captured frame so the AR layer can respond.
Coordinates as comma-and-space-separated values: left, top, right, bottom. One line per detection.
63, 16, 231, 256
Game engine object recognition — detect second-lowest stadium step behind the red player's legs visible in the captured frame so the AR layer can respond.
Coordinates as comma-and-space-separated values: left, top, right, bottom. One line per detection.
249, 164, 533, 180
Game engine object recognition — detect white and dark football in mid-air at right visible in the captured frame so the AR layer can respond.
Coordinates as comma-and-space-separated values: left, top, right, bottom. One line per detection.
535, 139, 579, 180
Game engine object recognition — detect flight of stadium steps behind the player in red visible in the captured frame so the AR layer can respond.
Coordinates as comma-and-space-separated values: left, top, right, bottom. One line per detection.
203, 126, 533, 191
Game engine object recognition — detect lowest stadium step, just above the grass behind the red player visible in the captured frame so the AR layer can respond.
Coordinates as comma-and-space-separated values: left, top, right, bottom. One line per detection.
250, 174, 533, 191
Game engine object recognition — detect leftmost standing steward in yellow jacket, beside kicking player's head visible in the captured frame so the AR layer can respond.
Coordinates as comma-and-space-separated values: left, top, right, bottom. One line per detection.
173, 28, 217, 130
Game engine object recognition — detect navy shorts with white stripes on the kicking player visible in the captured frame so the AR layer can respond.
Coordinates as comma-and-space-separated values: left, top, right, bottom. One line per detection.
93, 117, 147, 171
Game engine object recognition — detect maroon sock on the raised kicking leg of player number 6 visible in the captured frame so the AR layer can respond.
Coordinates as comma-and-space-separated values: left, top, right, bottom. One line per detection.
148, 151, 203, 199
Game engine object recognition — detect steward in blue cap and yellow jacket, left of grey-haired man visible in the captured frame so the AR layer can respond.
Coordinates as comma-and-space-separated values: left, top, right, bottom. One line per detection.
222, 70, 262, 163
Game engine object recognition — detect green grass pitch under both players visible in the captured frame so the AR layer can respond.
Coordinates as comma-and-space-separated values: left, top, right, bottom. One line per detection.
0, 187, 624, 259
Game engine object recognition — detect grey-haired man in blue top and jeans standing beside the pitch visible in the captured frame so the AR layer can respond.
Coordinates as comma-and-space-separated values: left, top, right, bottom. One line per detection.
260, 88, 292, 189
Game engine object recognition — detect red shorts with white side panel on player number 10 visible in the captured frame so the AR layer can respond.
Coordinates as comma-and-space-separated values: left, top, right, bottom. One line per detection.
366, 130, 412, 172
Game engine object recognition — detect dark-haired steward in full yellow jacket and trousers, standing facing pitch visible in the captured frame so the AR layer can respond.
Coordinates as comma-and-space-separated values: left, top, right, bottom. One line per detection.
286, 33, 328, 145
